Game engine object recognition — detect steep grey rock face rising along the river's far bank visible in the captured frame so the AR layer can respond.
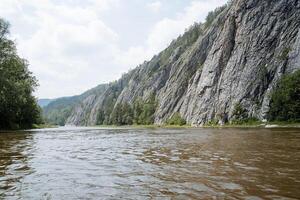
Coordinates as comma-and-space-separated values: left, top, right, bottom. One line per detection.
48, 0, 300, 125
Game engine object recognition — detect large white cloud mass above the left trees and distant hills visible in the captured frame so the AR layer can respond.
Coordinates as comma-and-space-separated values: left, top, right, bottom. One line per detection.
0, 0, 119, 97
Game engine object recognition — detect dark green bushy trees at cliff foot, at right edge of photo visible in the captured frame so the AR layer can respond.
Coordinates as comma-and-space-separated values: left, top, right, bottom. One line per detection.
268, 70, 300, 122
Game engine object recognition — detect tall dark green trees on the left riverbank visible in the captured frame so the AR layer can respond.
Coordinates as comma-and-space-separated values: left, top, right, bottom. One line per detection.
0, 19, 42, 129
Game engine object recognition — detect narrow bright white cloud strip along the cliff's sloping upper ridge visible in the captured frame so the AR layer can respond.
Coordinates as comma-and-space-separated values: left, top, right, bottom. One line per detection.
117, 0, 227, 69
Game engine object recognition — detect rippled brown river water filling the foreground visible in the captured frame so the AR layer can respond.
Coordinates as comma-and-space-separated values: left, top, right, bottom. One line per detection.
0, 128, 300, 199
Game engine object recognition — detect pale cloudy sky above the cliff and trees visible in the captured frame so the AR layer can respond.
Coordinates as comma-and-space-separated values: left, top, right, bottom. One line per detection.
0, 0, 227, 98
